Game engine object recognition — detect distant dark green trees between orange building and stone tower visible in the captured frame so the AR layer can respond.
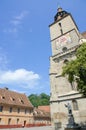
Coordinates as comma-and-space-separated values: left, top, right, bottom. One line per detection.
28, 93, 50, 107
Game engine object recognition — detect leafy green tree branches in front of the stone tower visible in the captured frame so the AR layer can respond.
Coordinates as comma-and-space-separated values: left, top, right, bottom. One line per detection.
62, 43, 86, 97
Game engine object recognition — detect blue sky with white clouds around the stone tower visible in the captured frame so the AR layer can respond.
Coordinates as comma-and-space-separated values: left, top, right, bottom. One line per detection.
0, 0, 86, 95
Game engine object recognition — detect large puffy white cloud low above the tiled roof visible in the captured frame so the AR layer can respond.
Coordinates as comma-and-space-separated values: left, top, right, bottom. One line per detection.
0, 69, 40, 88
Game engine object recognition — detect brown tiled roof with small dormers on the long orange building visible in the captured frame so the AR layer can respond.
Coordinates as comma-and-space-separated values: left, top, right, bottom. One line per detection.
0, 88, 33, 108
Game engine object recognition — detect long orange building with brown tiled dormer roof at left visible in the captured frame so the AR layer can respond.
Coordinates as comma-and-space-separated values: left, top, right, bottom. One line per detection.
0, 89, 33, 128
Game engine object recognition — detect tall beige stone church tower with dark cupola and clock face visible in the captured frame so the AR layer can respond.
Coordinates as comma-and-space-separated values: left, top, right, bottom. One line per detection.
49, 7, 86, 128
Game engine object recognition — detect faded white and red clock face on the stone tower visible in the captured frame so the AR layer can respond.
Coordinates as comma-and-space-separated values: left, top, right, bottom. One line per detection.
56, 33, 72, 49
